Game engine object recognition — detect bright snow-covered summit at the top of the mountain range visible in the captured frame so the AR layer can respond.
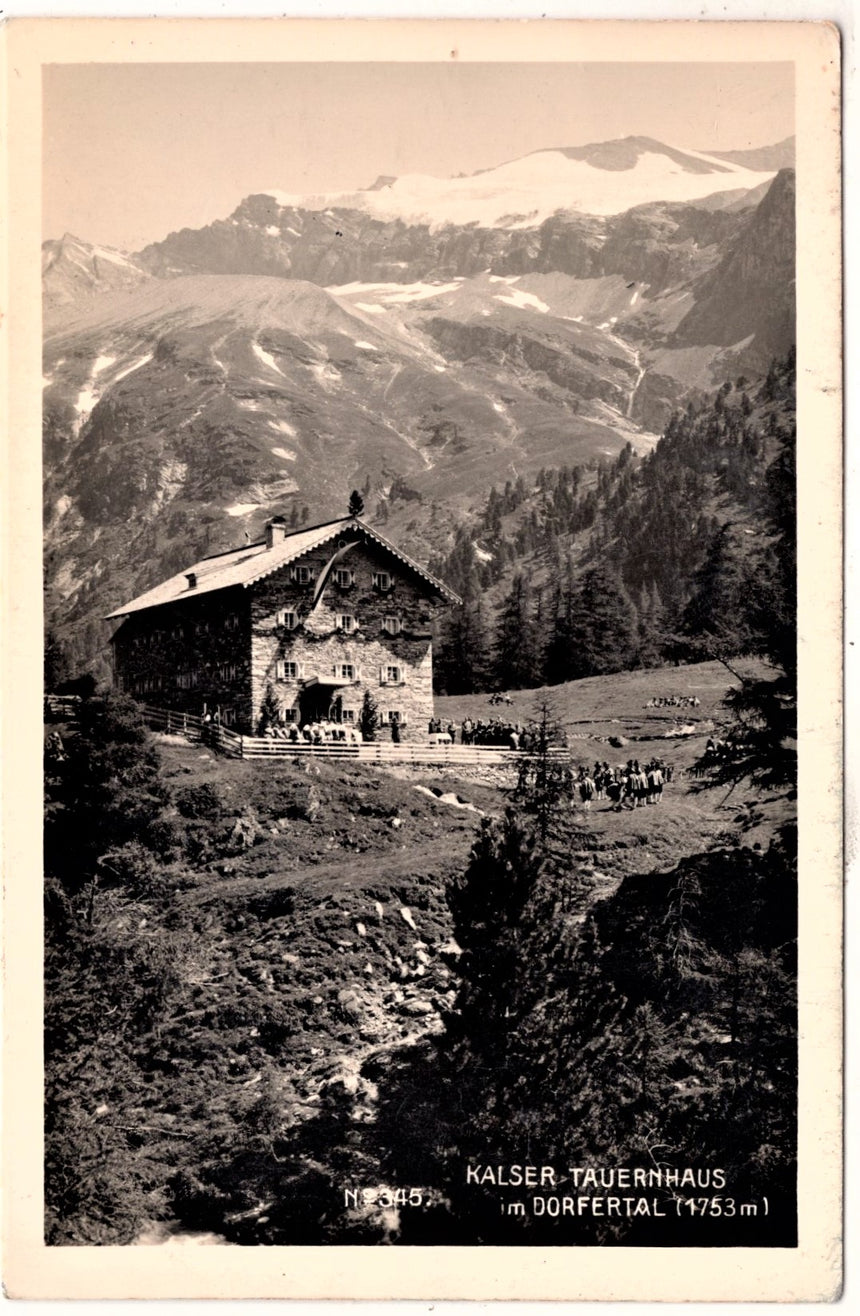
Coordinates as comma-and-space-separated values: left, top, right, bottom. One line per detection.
252, 137, 776, 229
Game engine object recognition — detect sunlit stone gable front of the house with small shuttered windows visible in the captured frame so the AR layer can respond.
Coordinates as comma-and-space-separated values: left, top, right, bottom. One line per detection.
250, 542, 437, 741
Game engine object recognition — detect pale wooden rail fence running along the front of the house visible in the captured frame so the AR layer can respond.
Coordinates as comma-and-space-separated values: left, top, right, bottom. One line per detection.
144, 707, 570, 767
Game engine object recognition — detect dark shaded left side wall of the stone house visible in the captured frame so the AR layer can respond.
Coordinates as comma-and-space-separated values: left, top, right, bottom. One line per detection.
113, 588, 252, 729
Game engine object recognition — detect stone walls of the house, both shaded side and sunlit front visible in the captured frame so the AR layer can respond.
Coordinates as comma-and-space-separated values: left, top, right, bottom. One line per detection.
113, 526, 444, 741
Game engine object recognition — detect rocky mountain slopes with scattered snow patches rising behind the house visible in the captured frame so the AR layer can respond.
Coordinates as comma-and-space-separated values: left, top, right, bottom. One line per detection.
43, 138, 794, 679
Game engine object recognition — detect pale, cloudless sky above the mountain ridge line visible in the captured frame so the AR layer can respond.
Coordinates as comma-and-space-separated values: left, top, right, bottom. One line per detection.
42, 62, 794, 251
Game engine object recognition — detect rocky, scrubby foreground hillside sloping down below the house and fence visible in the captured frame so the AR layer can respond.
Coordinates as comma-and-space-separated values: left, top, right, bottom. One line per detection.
46, 665, 793, 1245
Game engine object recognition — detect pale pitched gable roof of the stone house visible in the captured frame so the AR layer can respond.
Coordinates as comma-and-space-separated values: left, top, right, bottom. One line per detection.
108, 516, 460, 620
